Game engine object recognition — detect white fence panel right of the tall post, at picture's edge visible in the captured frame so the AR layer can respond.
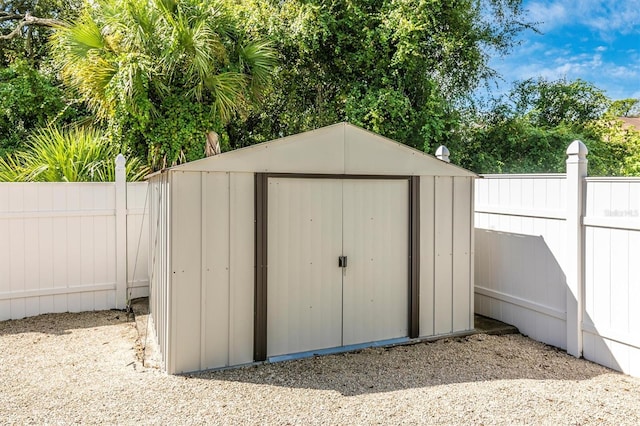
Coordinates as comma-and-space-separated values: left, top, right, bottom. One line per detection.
583, 178, 640, 376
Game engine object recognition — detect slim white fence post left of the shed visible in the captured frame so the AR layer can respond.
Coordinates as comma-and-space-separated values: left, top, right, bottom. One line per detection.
116, 154, 128, 309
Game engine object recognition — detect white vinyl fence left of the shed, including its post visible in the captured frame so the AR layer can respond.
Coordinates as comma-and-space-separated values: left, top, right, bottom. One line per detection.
0, 158, 149, 321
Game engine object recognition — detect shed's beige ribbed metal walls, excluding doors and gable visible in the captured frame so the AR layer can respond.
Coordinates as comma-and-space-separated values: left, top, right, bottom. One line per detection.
150, 170, 473, 373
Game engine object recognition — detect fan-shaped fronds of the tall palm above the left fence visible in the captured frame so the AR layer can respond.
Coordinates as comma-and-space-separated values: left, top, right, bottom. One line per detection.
52, 0, 276, 140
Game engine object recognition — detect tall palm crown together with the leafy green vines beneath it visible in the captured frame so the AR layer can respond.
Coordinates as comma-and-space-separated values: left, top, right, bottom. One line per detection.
52, 0, 274, 168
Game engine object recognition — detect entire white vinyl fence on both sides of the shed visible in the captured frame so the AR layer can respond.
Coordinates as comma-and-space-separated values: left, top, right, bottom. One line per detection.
0, 143, 640, 376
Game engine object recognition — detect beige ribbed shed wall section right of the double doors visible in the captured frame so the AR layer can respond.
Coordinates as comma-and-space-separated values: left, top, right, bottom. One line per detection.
420, 176, 474, 337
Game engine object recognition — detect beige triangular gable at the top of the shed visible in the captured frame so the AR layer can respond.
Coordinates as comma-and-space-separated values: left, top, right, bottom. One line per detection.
171, 123, 476, 176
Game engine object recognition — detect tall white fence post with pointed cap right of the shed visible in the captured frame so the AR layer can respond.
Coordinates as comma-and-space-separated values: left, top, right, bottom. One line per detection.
565, 140, 589, 357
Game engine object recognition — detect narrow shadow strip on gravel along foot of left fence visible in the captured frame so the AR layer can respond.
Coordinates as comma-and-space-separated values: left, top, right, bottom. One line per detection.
0, 310, 133, 337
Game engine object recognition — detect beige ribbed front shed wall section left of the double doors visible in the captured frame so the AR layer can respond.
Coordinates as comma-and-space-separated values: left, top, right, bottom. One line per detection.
166, 171, 254, 373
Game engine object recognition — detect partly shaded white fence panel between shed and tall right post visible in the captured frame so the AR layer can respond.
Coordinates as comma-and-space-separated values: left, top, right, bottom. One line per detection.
475, 175, 566, 348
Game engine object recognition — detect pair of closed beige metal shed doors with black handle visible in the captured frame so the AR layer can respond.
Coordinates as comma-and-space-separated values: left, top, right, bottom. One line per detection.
267, 177, 409, 356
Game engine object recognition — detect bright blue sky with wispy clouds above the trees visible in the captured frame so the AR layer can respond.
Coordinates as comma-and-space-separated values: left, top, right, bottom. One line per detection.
490, 0, 640, 99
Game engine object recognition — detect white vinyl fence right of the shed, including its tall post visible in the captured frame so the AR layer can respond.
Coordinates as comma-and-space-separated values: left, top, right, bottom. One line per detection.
475, 143, 640, 376
